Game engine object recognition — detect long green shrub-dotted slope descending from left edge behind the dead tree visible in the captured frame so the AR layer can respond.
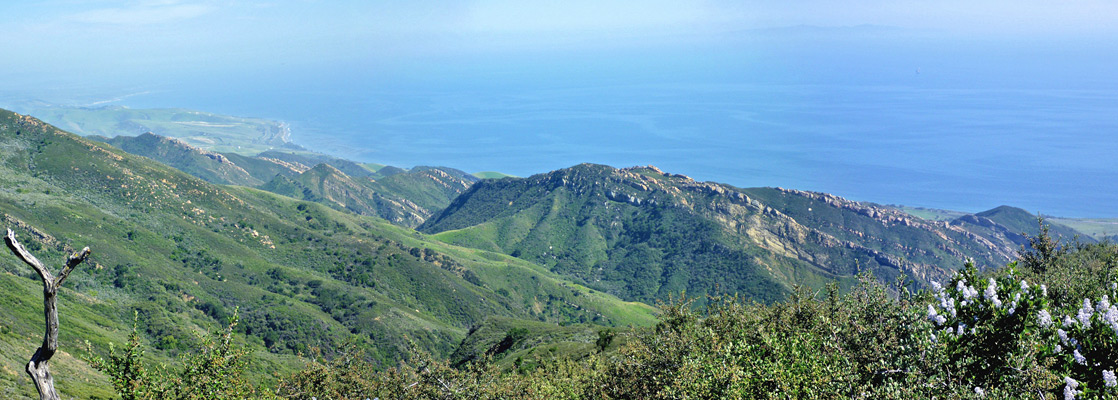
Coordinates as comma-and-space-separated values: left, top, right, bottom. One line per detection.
0, 111, 652, 396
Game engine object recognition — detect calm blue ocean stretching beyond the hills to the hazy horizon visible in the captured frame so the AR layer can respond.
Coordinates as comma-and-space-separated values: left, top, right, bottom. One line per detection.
8, 36, 1118, 218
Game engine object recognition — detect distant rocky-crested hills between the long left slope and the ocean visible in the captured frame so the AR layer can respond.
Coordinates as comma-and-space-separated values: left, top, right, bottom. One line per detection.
95, 133, 479, 227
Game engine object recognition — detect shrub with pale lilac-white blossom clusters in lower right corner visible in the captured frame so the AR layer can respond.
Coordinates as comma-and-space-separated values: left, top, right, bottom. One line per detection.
927, 264, 1118, 399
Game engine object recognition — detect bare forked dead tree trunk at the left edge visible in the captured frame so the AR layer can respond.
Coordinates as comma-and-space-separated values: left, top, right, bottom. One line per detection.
3, 229, 89, 400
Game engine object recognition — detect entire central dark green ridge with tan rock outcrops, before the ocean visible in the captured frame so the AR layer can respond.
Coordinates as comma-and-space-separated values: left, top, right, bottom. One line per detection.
418, 164, 1064, 303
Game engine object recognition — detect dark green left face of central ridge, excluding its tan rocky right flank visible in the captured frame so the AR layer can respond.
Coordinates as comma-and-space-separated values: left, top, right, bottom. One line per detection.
420, 165, 854, 303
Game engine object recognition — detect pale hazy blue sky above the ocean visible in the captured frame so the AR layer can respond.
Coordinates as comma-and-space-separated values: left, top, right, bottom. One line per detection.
0, 0, 1118, 91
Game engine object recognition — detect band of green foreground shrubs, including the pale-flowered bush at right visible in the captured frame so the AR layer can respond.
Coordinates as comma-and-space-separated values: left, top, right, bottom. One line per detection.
91, 234, 1118, 399
